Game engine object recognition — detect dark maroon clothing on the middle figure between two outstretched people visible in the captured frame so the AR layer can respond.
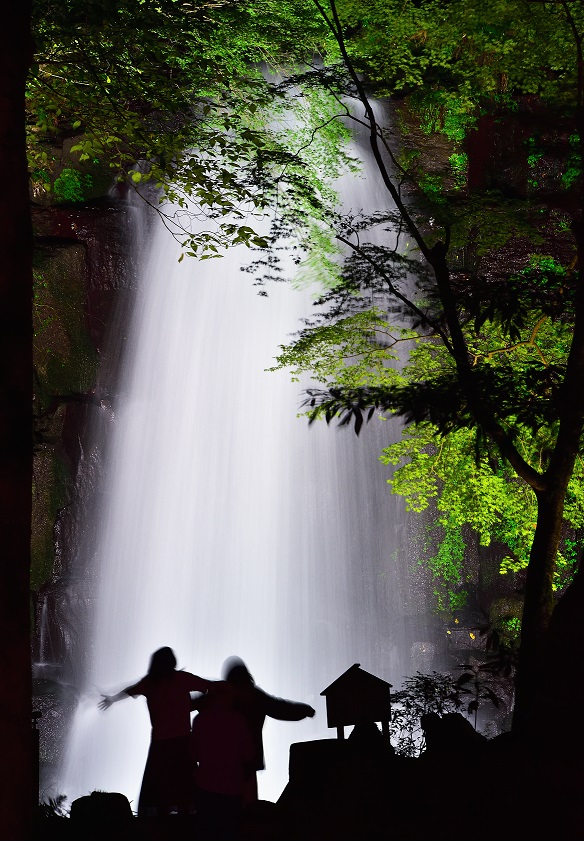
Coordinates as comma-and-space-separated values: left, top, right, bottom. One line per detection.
192, 707, 254, 796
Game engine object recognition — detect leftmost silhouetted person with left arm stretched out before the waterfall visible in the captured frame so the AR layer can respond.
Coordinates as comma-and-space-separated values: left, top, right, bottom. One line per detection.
99, 647, 212, 817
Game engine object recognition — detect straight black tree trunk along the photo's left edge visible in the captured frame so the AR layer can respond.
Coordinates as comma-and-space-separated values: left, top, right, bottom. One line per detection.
0, 0, 33, 841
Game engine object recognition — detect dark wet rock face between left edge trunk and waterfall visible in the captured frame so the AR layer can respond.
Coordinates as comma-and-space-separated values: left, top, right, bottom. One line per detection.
31, 190, 146, 785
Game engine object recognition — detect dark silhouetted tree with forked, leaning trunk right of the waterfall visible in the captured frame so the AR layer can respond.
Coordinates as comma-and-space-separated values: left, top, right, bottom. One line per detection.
280, 0, 584, 733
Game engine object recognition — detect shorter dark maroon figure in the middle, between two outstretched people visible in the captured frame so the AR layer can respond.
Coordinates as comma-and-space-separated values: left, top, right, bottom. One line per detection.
191, 684, 255, 841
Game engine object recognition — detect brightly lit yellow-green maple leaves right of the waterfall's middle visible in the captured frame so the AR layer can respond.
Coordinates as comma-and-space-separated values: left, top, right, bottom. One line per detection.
275, 298, 584, 612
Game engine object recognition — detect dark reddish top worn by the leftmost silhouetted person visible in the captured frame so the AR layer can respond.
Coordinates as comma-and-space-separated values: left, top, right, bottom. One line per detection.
126, 671, 211, 742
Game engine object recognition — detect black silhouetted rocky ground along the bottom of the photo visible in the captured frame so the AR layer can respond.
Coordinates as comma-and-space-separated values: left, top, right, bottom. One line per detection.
35, 722, 584, 841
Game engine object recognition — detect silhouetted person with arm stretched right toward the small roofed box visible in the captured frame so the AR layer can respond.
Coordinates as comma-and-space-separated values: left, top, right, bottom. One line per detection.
205, 657, 314, 804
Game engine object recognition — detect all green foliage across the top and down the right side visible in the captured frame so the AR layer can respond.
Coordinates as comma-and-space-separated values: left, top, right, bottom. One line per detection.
27, 0, 584, 648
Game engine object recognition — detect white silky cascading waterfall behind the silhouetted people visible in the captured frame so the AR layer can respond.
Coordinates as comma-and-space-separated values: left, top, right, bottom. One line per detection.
59, 131, 434, 805
